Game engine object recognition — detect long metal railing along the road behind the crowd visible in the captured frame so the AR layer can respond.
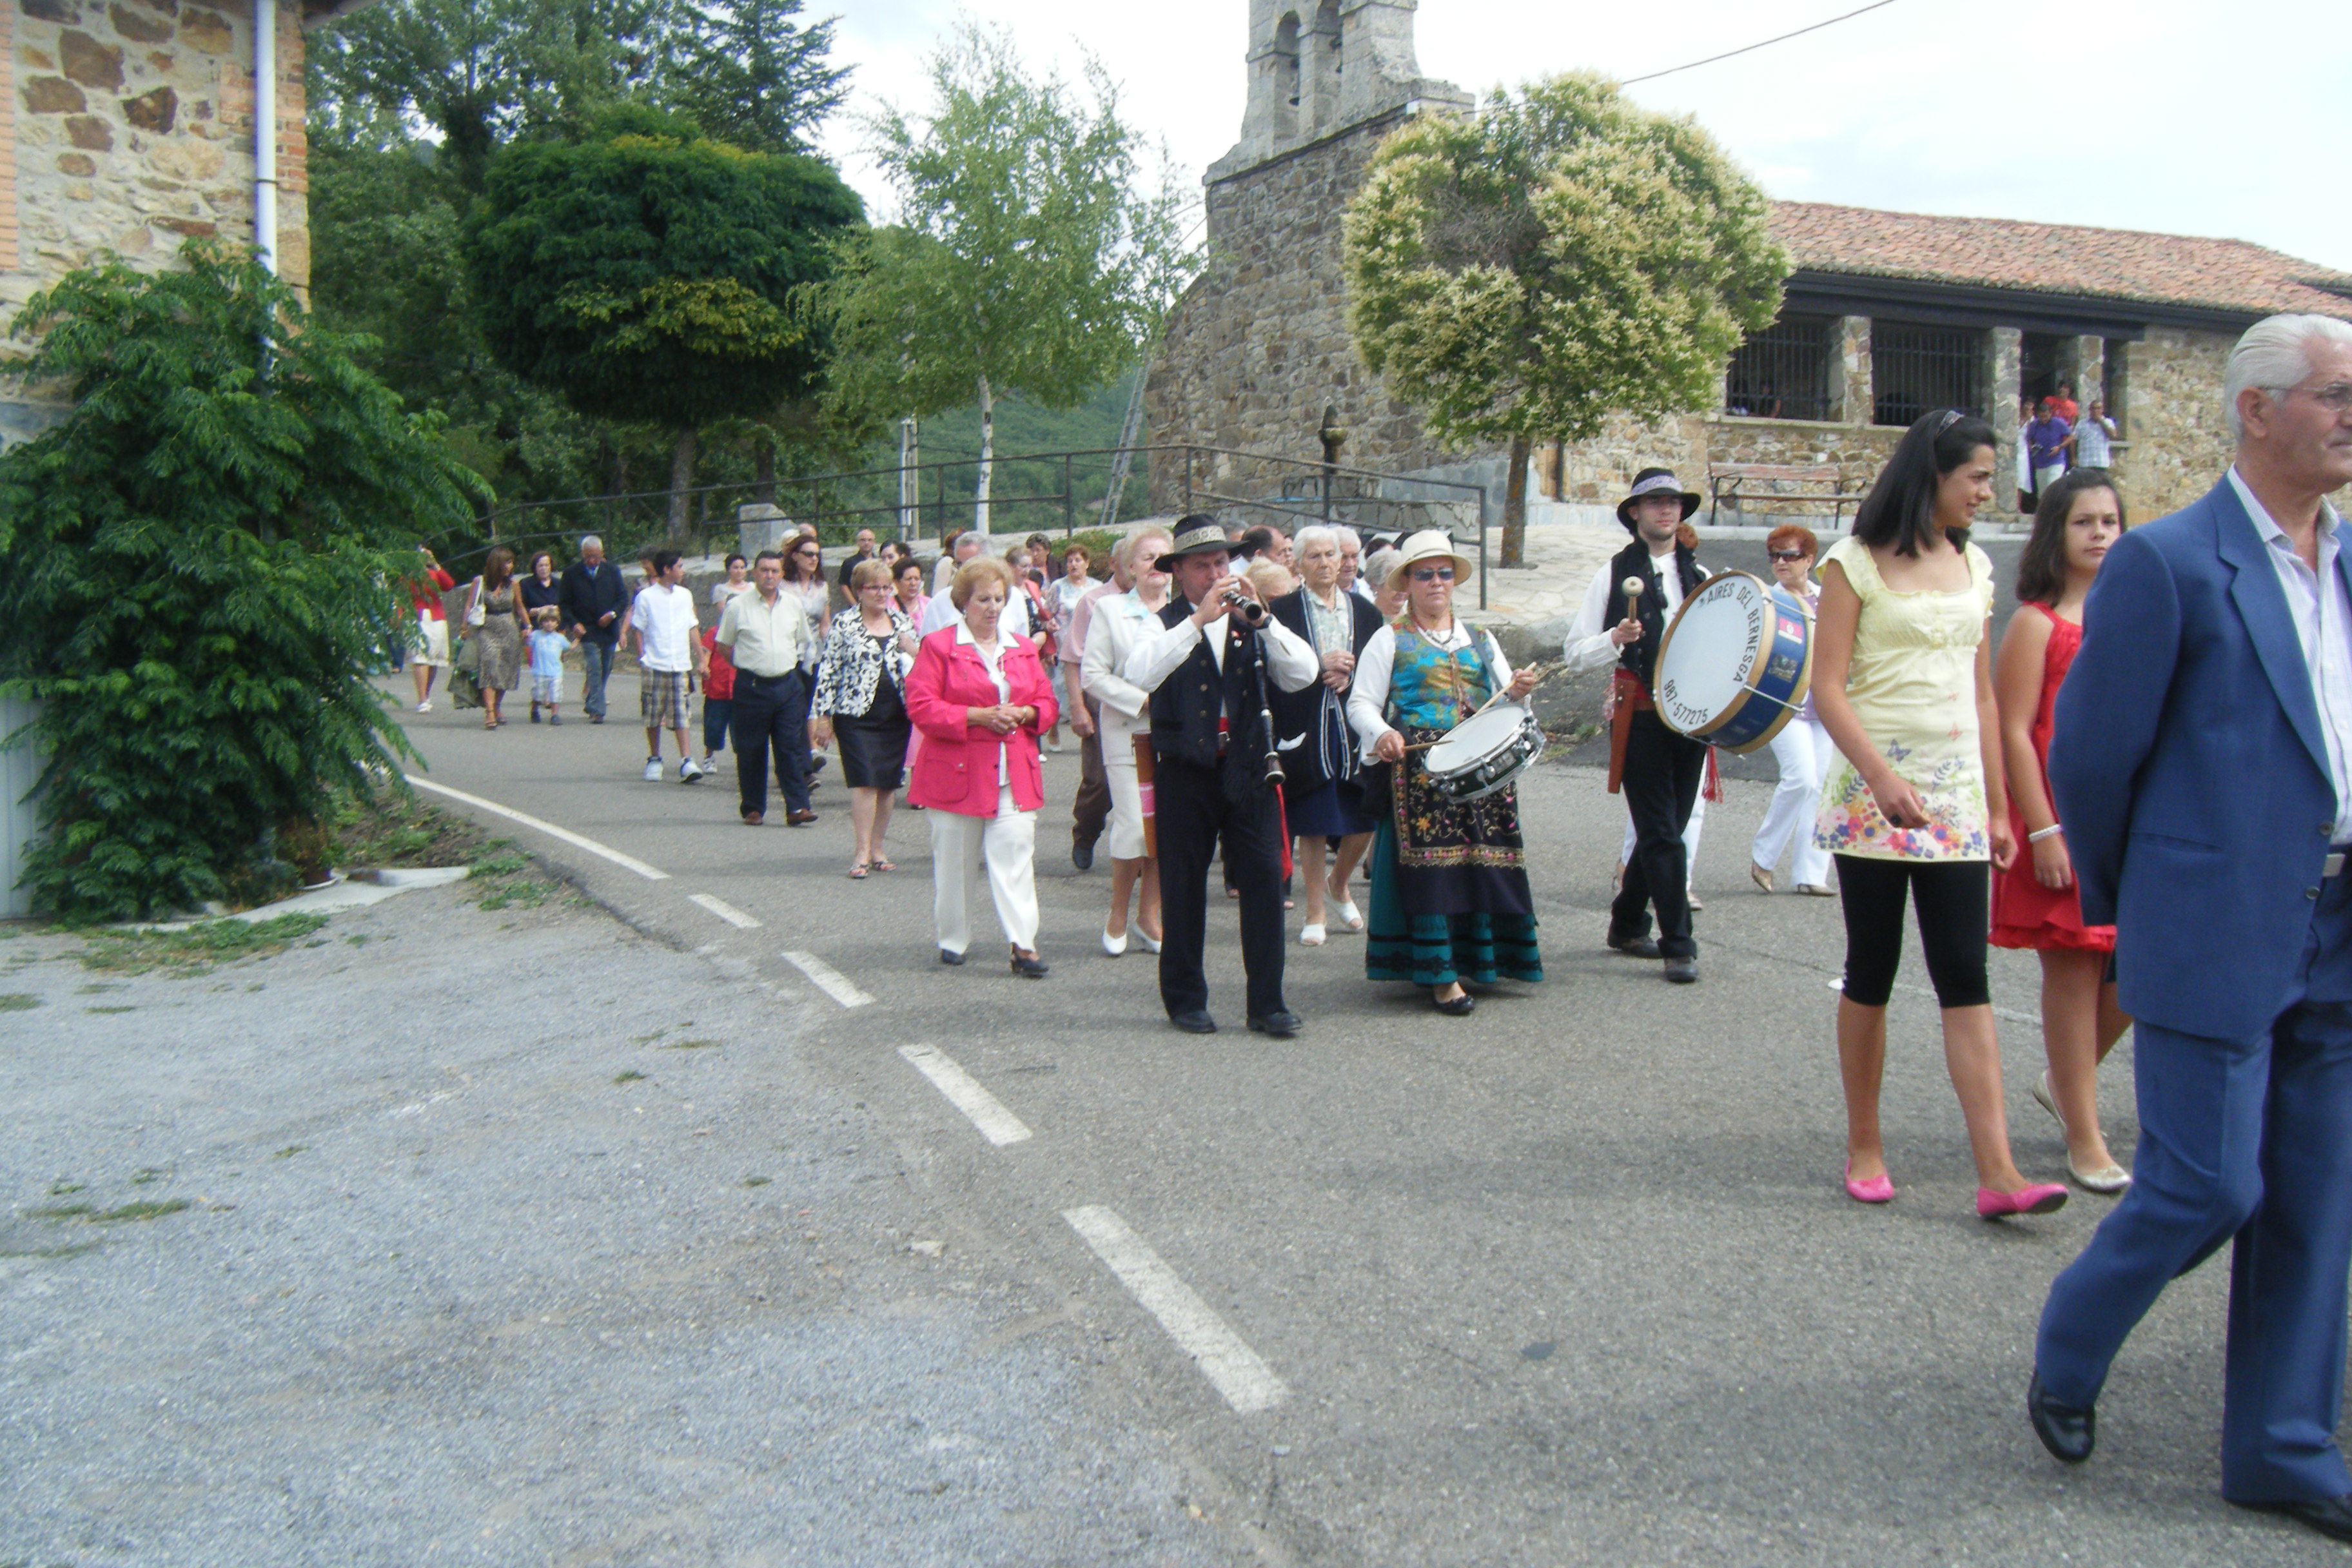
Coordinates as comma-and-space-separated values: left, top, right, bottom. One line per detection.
442, 444, 1487, 609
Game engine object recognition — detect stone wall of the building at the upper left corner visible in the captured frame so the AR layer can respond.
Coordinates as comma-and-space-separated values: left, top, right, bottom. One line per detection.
0, 0, 311, 440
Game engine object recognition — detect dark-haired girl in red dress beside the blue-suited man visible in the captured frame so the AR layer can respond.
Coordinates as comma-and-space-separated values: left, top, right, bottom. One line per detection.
1992, 468, 2131, 1192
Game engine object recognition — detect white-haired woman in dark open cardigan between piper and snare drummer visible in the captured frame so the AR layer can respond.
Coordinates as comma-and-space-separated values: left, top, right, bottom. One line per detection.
1270, 524, 1380, 947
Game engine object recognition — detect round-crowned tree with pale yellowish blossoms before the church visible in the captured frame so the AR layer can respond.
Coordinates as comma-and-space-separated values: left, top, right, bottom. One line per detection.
1346, 75, 1787, 567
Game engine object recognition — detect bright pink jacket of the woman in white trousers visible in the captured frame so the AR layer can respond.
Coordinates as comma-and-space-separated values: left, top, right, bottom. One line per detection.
905, 621, 1061, 816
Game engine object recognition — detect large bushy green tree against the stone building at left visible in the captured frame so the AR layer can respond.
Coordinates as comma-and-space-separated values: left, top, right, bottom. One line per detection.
0, 240, 478, 921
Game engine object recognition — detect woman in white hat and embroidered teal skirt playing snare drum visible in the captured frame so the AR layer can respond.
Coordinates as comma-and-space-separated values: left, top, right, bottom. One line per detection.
1348, 531, 1543, 1018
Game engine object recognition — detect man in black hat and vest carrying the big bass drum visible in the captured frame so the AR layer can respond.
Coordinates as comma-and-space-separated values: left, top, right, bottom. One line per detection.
1564, 468, 1707, 980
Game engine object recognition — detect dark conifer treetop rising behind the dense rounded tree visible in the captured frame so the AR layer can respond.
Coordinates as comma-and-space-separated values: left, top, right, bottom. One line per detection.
654, 0, 849, 153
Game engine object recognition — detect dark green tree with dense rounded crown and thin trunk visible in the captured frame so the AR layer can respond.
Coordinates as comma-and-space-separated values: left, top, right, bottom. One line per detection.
466, 106, 863, 536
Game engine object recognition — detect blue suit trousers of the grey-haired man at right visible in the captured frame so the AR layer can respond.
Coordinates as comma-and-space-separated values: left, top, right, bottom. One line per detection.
2035, 877, 2352, 1502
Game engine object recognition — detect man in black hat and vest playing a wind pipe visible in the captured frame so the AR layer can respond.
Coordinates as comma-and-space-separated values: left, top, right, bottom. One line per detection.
1122, 515, 1322, 1034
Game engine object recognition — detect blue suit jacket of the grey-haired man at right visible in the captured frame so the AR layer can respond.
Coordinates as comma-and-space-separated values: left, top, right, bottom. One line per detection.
2048, 480, 2352, 1039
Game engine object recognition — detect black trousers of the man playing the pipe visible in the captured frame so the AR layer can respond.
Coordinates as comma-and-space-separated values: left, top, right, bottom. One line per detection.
1153, 754, 1286, 1018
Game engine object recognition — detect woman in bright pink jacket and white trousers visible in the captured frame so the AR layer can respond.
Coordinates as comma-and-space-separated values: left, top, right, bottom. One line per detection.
905, 557, 1059, 980
